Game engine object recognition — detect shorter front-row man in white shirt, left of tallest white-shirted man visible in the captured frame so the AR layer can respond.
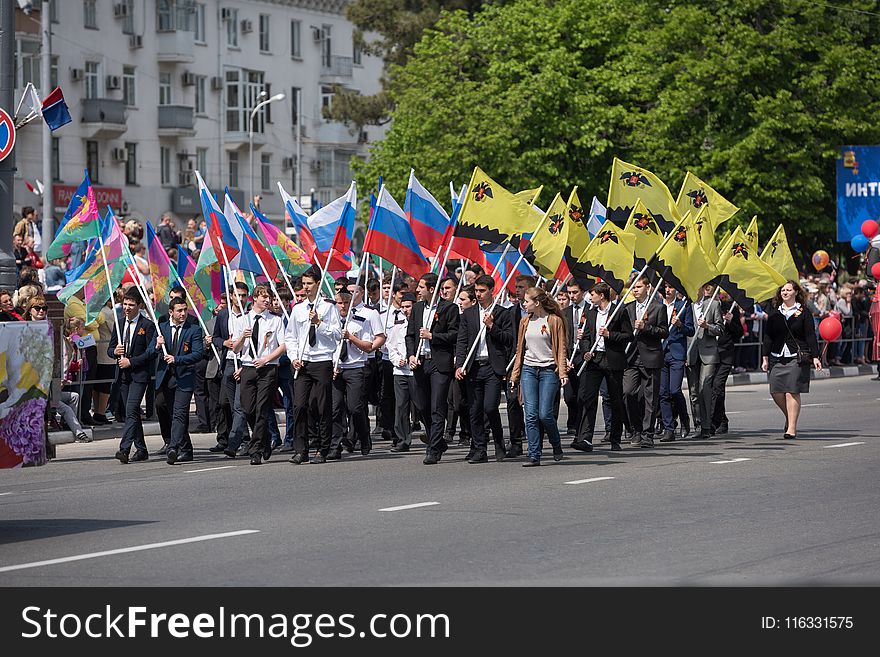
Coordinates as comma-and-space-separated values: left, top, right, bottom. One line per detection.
233, 285, 286, 465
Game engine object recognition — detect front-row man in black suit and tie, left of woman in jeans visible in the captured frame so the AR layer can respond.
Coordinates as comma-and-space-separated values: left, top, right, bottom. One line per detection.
455, 274, 514, 463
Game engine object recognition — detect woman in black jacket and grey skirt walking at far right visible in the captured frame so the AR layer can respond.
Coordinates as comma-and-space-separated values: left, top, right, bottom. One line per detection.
761, 281, 822, 439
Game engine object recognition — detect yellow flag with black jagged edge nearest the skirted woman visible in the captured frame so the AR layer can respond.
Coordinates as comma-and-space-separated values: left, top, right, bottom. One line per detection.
718, 226, 785, 309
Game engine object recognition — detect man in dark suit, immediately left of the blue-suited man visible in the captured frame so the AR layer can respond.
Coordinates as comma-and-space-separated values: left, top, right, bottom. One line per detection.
623, 276, 669, 447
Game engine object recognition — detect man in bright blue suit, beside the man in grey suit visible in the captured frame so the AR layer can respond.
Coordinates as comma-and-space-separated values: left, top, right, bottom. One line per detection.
660, 283, 694, 443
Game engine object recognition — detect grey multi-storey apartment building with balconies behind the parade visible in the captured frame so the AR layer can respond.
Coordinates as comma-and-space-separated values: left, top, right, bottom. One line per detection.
15, 0, 384, 231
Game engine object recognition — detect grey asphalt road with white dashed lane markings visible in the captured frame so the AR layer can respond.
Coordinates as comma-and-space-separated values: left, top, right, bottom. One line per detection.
0, 376, 880, 586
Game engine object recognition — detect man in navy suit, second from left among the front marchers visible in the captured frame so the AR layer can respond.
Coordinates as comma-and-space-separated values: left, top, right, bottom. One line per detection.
155, 299, 205, 465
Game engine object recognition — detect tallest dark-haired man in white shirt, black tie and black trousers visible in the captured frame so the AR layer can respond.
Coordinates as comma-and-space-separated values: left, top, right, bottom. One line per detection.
285, 266, 342, 465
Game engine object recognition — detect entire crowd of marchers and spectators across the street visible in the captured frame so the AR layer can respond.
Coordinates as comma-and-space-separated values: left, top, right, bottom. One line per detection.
0, 208, 874, 467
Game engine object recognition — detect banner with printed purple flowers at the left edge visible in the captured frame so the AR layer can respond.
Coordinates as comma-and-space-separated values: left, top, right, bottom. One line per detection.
0, 321, 53, 468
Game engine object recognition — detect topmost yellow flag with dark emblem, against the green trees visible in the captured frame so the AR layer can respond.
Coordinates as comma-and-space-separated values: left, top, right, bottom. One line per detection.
607, 157, 680, 233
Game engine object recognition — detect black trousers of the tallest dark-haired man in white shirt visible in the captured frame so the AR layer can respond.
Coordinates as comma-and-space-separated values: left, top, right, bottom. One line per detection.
293, 360, 333, 456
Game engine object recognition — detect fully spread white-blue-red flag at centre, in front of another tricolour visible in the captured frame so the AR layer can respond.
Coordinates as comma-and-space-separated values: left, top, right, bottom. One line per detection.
364, 184, 432, 279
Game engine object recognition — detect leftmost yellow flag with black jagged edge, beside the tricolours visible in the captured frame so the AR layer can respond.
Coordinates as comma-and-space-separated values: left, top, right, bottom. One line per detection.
455, 167, 535, 244
